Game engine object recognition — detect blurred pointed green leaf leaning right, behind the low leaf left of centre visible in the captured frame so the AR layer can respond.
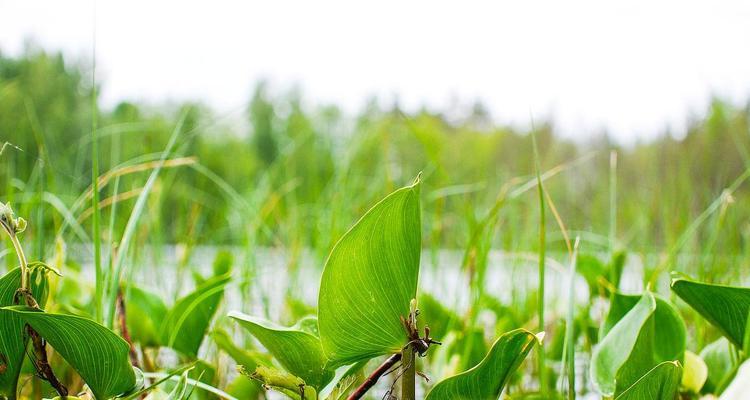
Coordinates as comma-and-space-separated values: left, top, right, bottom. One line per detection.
160, 275, 231, 358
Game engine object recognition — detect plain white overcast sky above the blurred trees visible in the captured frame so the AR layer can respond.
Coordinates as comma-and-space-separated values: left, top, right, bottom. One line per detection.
0, 0, 750, 141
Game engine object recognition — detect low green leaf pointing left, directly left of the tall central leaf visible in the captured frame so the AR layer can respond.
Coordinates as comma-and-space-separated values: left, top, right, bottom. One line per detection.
229, 312, 334, 391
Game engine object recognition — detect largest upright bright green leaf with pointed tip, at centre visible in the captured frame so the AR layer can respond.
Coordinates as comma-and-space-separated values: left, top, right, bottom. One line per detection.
318, 178, 422, 366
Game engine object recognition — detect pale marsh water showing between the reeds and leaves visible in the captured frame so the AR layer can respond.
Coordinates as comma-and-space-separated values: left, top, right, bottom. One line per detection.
69, 246, 656, 320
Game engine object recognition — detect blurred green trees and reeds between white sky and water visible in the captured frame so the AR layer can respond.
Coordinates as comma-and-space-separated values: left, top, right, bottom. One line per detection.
0, 48, 750, 252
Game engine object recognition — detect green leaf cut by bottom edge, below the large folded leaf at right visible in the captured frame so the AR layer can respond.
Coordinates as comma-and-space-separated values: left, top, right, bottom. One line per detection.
615, 361, 682, 400
